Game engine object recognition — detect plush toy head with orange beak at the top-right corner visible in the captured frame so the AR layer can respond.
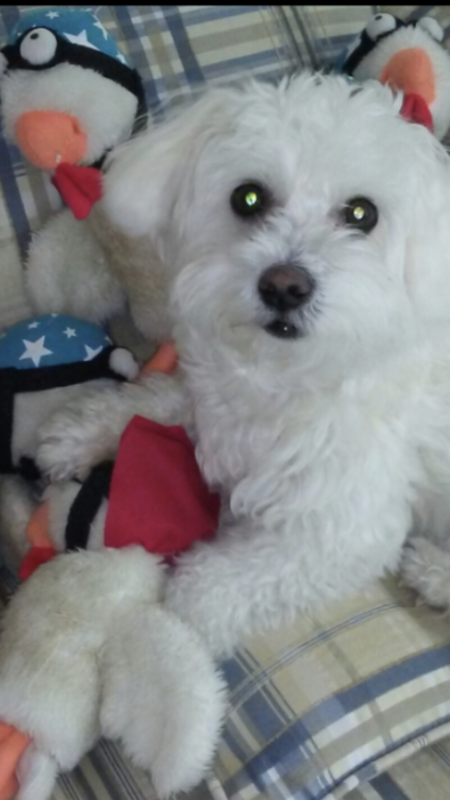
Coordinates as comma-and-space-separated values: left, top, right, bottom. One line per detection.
342, 14, 450, 139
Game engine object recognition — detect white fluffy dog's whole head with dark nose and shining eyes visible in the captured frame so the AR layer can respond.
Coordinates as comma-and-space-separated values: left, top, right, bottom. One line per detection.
105, 76, 450, 384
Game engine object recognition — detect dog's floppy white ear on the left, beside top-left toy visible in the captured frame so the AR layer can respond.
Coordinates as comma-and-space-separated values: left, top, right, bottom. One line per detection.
102, 89, 221, 239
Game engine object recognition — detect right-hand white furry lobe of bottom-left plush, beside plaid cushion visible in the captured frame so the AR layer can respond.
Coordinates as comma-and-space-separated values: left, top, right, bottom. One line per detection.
100, 606, 226, 798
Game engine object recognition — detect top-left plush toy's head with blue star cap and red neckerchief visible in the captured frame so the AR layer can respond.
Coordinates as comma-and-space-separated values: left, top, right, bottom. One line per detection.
0, 6, 146, 219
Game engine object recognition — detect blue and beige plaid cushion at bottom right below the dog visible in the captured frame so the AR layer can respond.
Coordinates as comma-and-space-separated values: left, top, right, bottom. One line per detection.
210, 578, 450, 800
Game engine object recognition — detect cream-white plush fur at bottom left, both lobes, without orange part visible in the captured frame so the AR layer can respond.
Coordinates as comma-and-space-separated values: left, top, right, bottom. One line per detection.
0, 547, 225, 800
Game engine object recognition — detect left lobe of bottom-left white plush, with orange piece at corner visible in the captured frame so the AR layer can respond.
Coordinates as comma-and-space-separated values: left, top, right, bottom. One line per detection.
0, 547, 163, 800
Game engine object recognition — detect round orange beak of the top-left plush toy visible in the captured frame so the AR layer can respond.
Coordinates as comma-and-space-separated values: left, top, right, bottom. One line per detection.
15, 111, 87, 170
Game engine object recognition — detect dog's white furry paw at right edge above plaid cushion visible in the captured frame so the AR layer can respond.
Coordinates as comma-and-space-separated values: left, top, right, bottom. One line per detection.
401, 536, 450, 610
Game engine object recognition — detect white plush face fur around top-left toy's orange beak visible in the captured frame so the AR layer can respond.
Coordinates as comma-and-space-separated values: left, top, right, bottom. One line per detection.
2, 64, 137, 164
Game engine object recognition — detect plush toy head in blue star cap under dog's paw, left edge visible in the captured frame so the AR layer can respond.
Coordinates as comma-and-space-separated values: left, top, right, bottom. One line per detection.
0, 314, 139, 564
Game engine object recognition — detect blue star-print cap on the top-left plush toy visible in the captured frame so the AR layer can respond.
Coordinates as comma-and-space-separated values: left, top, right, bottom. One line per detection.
8, 6, 127, 64
